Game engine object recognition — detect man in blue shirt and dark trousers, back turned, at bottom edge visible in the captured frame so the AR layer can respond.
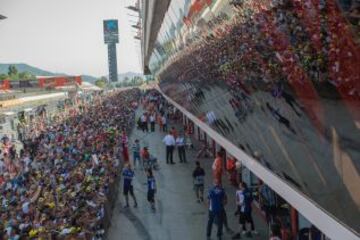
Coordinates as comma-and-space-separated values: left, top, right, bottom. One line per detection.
206, 179, 227, 239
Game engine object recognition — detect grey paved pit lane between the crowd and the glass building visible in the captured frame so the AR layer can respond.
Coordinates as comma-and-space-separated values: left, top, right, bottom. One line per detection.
108, 109, 267, 240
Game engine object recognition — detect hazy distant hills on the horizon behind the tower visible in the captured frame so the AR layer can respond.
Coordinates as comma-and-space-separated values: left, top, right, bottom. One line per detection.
0, 63, 97, 83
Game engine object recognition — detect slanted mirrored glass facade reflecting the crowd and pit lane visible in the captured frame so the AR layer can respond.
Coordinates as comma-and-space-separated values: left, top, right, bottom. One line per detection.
150, 0, 360, 232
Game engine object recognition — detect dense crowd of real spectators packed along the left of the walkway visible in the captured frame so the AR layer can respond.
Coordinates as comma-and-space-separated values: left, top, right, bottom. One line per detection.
0, 89, 140, 240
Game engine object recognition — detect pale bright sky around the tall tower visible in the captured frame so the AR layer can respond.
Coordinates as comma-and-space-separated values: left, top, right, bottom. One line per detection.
0, 0, 141, 77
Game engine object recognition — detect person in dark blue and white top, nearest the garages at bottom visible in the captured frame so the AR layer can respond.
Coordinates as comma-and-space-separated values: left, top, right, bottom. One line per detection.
233, 182, 258, 239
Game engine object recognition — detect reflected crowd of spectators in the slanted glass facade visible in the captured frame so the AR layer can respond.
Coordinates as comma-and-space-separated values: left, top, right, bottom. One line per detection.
160, 0, 360, 127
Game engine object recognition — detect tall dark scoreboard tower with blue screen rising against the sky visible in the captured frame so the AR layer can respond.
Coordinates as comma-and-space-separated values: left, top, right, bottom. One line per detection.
104, 19, 119, 82
